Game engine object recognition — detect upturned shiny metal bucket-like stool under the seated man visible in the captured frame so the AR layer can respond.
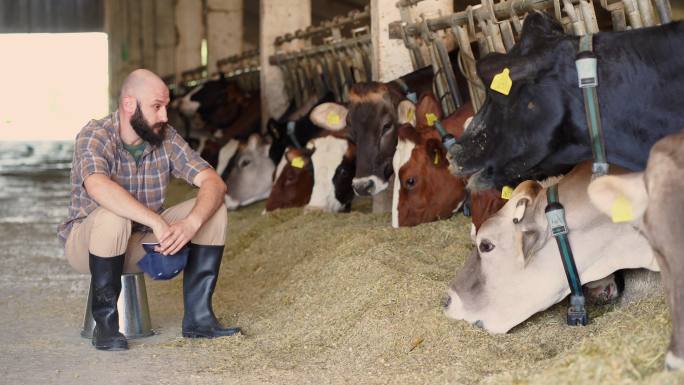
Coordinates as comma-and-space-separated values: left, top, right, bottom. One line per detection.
81, 273, 154, 339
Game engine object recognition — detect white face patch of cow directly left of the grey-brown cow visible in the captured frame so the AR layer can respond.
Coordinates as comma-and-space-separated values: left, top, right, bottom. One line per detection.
307, 136, 349, 213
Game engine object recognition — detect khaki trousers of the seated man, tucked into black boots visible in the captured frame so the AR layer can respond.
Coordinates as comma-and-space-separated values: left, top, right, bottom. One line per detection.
64, 199, 228, 273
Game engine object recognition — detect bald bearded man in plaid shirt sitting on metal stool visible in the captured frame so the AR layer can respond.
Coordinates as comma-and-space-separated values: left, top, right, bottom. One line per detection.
58, 69, 240, 350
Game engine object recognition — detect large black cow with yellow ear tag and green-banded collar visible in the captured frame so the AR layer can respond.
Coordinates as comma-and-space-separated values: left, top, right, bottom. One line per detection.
450, 11, 684, 189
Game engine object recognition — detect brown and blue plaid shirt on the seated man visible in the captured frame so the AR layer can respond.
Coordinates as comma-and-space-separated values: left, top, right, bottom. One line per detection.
57, 110, 211, 241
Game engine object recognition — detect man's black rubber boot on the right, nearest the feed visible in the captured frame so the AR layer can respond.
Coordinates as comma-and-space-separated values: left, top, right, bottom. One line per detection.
183, 243, 240, 338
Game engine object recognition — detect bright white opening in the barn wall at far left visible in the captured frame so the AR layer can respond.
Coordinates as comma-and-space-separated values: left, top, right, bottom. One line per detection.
0, 33, 109, 141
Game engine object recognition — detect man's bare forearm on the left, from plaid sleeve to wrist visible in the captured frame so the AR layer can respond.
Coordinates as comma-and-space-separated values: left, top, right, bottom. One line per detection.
84, 174, 161, 228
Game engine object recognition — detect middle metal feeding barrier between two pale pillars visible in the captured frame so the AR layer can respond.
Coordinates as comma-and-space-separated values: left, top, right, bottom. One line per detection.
269, 7, 372, 107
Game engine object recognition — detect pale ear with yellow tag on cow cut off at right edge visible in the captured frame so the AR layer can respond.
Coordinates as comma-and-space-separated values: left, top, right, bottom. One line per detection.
587, 172, 648, 222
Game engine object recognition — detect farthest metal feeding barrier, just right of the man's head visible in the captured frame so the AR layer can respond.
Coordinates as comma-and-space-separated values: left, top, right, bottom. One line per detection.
162, 50, 261, 94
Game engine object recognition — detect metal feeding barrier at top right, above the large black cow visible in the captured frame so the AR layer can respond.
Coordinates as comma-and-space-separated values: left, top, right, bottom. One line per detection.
389, 0, 672, 115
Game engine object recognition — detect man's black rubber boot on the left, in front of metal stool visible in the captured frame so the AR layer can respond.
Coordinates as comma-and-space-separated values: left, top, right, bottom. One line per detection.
90, 254, 128, 350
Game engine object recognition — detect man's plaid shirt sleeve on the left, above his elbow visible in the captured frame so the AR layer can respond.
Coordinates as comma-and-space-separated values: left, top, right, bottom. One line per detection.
75, 124, 111, 183
